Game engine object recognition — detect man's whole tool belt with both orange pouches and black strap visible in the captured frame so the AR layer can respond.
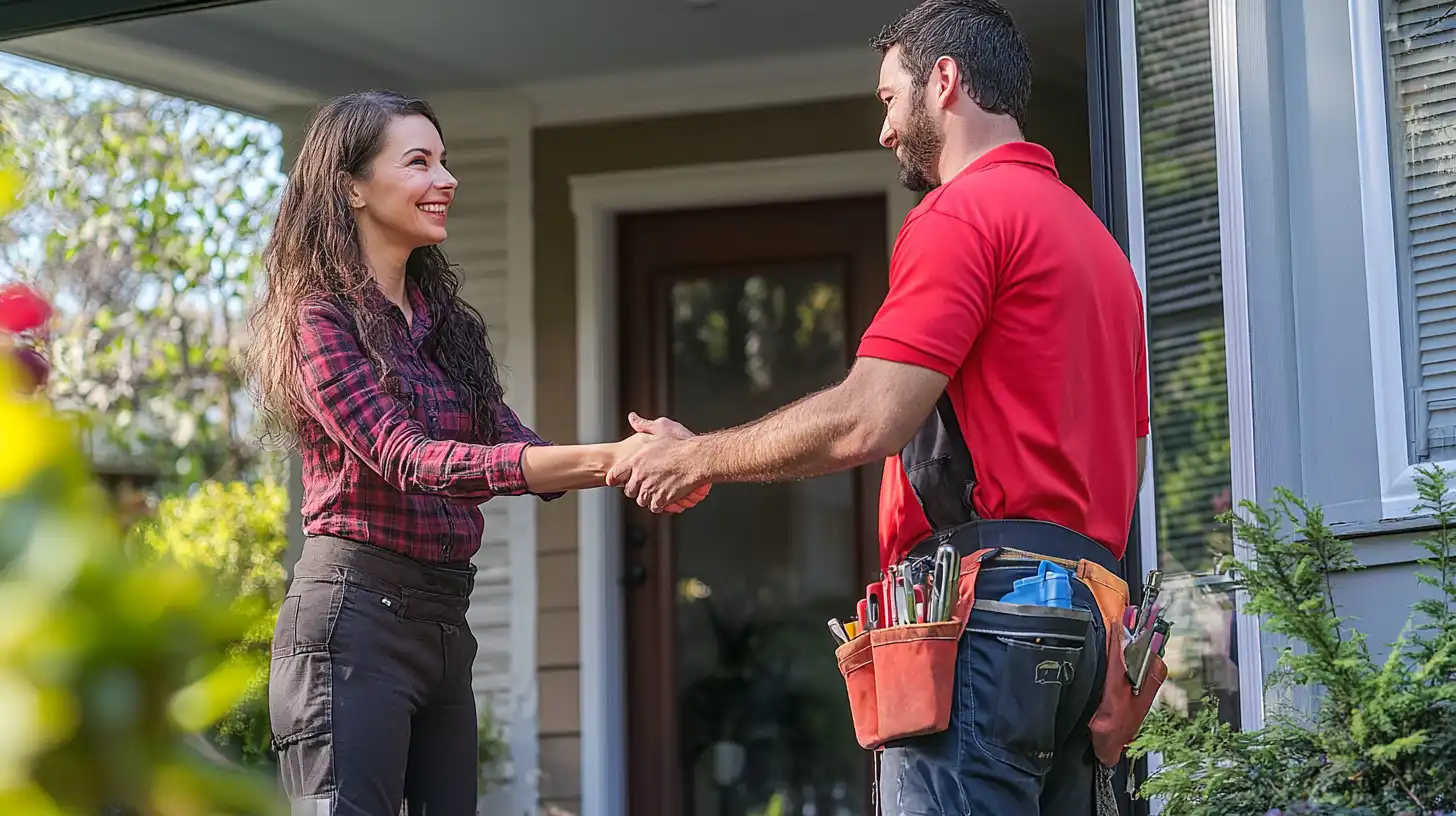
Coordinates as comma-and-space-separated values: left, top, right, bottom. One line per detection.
834, 395, 1168, 768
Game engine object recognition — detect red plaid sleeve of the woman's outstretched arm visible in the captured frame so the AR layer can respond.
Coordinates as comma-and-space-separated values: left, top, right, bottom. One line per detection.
298, 302, 534, 501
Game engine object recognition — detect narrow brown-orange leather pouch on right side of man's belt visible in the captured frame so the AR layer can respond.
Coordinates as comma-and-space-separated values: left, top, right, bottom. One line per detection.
1077, 560, 1168, 768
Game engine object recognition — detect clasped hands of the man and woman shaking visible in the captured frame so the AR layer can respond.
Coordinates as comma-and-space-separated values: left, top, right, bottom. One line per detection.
607, 414, 712, 513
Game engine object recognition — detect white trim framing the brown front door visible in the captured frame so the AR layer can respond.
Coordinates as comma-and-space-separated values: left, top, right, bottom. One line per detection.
571, 150, 916, 816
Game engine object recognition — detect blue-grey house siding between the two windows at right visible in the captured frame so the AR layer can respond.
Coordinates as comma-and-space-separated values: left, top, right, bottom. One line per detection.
1236, 0, 1433, 693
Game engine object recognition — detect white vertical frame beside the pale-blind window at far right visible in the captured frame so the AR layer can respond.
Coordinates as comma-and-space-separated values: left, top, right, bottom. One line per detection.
1348, 0, 1456, 520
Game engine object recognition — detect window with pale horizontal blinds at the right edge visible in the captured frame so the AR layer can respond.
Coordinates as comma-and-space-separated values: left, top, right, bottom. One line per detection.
1382, 0, 1456, 463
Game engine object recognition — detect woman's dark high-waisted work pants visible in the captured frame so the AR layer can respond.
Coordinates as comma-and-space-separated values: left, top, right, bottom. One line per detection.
268, 538, 479, 816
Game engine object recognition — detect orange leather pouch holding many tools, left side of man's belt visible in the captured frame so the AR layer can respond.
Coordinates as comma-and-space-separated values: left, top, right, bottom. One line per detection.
834, 549, 996, 749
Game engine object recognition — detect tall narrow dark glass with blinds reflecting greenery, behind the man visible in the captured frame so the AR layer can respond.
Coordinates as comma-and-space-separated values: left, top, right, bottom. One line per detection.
1134, 0, 1239, 726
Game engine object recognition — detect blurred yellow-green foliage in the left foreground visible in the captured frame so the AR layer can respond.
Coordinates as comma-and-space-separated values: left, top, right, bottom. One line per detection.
0, 349, 280, 816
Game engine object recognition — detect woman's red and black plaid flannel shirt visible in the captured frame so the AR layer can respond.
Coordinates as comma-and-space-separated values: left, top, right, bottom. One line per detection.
298, 286, 561, 565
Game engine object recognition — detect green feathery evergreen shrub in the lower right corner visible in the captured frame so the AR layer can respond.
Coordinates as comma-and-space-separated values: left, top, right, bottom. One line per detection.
1130, 466, 1456, 816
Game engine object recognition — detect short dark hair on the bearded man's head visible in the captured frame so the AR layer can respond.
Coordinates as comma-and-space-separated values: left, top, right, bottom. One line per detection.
869, 0, 1031, 127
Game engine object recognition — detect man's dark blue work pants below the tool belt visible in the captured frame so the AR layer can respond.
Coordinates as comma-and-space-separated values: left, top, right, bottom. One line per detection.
879, 560, 1107, 816
